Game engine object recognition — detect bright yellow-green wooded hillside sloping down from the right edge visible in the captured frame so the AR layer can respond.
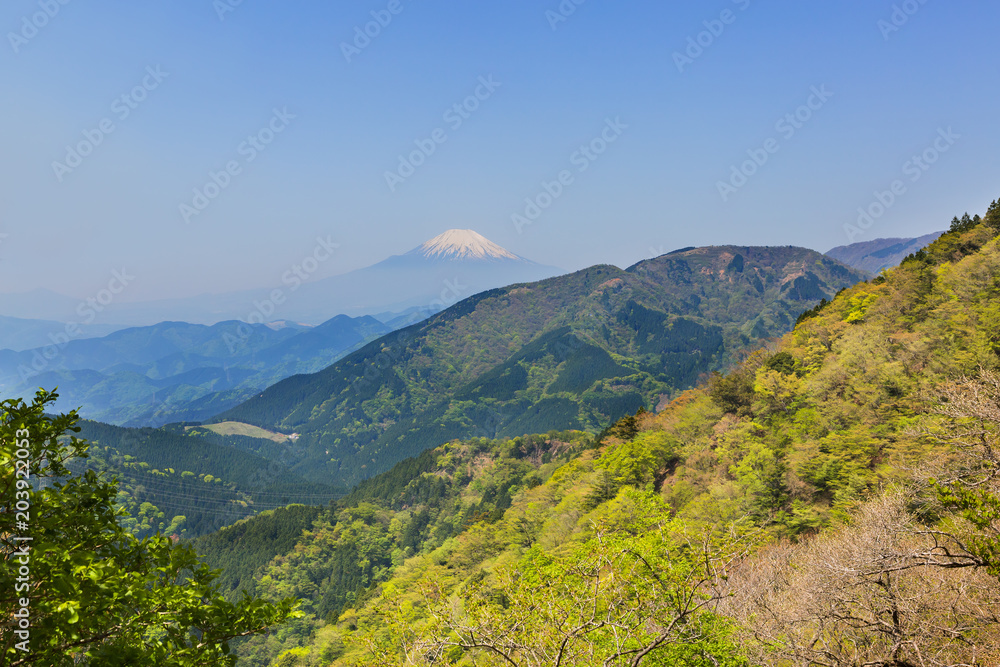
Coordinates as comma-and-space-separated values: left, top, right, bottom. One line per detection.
203, 204, 1000, 667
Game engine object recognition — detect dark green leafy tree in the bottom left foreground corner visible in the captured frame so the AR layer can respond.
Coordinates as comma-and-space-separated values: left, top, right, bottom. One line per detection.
0, 391, 298, 667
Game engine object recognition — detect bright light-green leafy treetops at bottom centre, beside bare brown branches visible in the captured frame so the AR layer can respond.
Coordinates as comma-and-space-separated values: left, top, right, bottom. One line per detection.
366, 489, 746, 667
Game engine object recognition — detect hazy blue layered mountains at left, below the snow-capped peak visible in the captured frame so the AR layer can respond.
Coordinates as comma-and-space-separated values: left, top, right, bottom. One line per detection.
0, 315, 392, 426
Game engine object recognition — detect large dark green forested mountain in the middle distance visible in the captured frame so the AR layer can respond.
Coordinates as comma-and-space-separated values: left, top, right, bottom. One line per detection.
215, 246, 862, 484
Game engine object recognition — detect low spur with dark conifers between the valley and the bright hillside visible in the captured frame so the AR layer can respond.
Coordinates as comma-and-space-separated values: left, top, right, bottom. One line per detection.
195, 432, 593, 665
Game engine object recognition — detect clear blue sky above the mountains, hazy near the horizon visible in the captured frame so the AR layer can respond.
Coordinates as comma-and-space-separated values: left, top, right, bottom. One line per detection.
0, 0, 1000, 301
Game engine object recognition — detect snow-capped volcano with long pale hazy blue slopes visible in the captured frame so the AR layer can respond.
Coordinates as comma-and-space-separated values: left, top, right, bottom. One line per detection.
0, 229, 562, 326
